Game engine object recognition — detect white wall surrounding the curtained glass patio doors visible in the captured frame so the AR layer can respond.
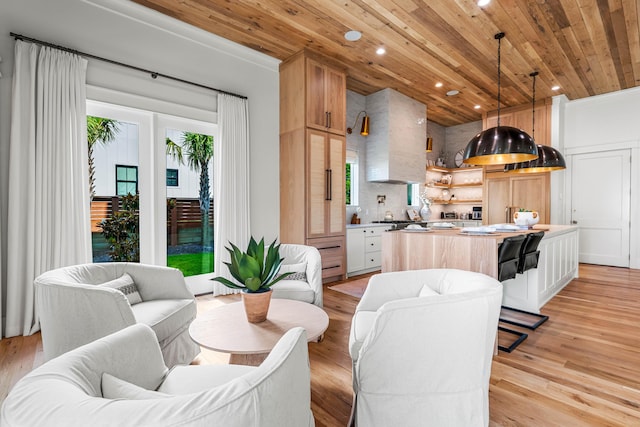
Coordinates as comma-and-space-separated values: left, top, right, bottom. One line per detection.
0, 0, 279, 279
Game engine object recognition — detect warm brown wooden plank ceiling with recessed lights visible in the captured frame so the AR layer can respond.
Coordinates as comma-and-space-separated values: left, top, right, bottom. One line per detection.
134, 0, 640, 126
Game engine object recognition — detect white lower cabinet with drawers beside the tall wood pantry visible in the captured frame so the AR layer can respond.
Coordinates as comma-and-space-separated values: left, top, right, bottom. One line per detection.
347, 224, 389, 276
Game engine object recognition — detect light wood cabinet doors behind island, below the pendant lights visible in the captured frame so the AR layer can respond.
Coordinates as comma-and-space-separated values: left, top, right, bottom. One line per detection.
482, 172, 551, 224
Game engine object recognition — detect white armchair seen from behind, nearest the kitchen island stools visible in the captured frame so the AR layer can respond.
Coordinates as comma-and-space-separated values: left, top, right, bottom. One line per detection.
349, 269, 502, 427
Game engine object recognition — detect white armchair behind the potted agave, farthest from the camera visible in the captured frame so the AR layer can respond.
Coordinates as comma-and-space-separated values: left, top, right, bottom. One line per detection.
271, 243, 323, 308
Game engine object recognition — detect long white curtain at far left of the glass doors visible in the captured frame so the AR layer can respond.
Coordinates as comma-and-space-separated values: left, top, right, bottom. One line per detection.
5, 41, 91, 337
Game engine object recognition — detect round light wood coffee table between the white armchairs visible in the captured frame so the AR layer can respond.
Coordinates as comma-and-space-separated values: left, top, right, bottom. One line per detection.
189, 298, 329, 365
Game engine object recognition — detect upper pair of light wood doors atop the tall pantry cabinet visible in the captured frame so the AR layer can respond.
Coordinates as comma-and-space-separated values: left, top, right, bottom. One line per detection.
306, 58, 347, 135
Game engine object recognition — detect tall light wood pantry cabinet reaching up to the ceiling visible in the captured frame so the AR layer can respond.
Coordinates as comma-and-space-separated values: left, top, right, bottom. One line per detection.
280, 51, 347, 282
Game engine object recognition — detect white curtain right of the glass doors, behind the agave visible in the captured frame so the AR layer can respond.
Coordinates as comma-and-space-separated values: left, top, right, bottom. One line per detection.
213, 94, 251, 295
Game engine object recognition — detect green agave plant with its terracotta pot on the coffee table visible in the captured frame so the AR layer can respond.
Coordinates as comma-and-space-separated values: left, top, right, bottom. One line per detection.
212, 236, 292, 323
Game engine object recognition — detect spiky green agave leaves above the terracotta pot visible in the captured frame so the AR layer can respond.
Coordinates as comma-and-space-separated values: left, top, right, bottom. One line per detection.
211, 236, 293, 292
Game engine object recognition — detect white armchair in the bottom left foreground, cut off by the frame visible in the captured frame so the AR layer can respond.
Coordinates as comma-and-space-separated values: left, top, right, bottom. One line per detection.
0, 324, 314, 427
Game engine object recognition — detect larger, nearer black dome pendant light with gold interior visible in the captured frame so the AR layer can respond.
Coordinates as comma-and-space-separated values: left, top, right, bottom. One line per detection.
462, 33, 538, 165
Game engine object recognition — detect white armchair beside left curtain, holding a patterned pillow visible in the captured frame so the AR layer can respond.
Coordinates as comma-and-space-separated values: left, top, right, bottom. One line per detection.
34, 262, 200, 366
